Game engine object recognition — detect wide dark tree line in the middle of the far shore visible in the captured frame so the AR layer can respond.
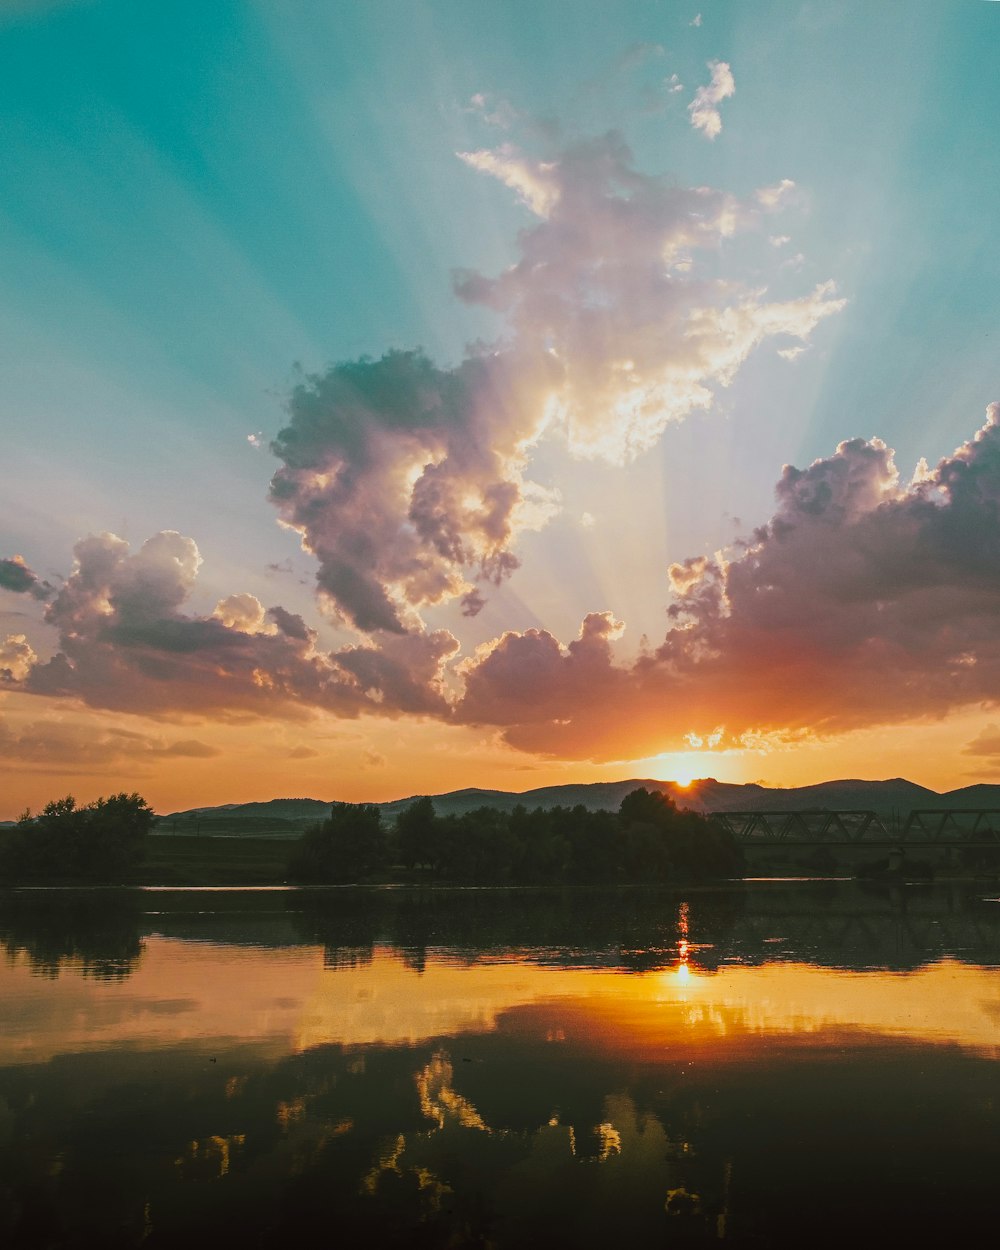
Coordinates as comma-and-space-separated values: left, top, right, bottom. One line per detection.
289, 788, 743, 885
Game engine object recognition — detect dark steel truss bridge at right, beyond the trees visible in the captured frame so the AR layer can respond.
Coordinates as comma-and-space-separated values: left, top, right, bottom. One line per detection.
706, 808, 1000, 849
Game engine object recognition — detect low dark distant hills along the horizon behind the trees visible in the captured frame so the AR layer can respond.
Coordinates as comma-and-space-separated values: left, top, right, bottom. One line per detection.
150, 778, 1000, 838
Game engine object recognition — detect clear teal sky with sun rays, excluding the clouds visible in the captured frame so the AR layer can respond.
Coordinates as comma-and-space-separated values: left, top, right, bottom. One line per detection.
0, 0, 1000, 810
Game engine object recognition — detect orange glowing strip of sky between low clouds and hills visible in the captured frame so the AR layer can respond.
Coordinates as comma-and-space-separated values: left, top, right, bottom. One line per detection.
0, 694, 996, 820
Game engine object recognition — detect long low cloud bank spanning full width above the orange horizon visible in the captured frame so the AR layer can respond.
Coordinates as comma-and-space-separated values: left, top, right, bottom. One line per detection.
17, 404, 1000, 766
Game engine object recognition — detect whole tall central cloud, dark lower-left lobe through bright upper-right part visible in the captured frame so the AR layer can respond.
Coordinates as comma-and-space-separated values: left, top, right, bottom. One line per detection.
271, 112, 843, 634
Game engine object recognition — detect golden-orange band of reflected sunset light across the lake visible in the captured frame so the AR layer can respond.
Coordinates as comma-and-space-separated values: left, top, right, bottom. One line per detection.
0, 930, 1000, 1064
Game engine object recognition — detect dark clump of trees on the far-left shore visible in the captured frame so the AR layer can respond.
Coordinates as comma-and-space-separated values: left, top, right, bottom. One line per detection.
3, 794, 156, 880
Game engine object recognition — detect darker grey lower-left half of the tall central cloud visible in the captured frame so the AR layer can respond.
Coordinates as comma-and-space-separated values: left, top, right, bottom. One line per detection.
271, 351, 553, 634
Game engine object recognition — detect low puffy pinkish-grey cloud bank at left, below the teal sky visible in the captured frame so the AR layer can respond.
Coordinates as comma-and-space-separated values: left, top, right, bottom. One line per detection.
15, 531, 458, 725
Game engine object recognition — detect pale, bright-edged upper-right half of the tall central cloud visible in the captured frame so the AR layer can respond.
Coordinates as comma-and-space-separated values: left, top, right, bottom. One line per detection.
456, 133, 844, 464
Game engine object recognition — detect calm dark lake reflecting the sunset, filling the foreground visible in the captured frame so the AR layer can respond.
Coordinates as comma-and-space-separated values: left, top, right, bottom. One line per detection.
0, 880, 1000, 1250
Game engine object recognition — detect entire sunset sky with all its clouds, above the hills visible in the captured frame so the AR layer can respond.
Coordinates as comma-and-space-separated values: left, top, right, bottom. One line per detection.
0, 0, 1000, 819
